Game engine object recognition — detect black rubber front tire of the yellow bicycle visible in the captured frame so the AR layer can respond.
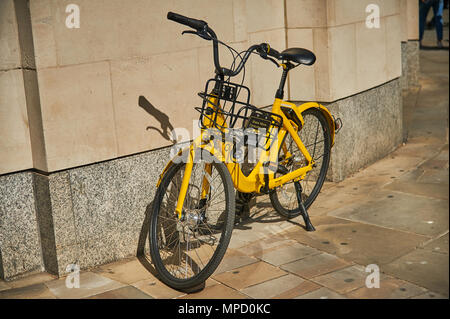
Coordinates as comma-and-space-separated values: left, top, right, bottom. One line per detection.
149, 150, 235, 291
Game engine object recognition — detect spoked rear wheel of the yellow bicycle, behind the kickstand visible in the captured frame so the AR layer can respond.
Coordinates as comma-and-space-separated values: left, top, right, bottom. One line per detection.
270, 108, 331, 218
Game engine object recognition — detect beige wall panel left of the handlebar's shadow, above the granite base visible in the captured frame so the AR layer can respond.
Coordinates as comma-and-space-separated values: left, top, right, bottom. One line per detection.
38, 62, 117, 171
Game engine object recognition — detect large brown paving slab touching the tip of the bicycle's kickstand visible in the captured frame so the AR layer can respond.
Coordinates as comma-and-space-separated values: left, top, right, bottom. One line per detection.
285, 216, 429, 265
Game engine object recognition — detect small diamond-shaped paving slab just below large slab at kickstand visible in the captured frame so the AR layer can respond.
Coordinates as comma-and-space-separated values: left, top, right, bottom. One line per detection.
281, 253, 350, 278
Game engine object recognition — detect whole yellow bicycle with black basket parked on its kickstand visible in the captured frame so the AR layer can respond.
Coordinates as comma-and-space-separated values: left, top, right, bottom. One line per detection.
149, 12, 341, 290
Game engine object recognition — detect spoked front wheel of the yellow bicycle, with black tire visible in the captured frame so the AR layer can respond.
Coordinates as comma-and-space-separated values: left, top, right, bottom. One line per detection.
149, 150, 235, 290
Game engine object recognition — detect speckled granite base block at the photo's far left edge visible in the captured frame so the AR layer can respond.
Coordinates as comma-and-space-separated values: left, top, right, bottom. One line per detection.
0, 172, 43, 280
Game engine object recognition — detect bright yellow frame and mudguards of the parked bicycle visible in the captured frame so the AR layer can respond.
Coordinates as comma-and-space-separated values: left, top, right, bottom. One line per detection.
157, 98, 334, 218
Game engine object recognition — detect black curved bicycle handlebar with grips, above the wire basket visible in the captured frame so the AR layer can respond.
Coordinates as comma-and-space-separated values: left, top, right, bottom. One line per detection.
167, 12, 280, 76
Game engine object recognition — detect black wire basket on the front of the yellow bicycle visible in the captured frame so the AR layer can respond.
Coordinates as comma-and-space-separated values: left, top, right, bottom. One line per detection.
195, 79, 283, 151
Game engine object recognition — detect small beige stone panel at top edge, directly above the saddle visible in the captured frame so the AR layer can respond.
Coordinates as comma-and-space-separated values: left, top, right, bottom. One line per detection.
286, 0, 327, 28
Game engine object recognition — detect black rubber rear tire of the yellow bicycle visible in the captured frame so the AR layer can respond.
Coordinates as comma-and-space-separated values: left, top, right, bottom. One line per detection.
269, 108, 331, 218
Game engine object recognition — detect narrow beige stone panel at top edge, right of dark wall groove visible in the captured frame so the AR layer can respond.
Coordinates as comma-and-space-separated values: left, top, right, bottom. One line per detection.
30, 0, 57, 69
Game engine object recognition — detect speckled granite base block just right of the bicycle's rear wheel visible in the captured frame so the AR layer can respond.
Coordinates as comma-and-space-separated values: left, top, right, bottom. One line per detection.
327, 79, 403, 181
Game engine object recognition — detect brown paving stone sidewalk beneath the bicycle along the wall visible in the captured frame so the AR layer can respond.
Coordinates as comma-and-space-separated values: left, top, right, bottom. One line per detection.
0, 28, 449, 299
